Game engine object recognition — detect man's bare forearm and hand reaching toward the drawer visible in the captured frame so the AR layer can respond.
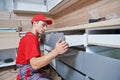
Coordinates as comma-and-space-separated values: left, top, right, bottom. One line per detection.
30, 39, 68, 70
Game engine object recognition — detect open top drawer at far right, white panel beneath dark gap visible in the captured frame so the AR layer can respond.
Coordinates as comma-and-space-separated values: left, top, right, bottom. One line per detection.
86, 26, 120, 48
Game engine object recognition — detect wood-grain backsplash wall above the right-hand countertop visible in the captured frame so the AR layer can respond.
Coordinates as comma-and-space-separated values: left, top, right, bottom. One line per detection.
54, 0, 120, 28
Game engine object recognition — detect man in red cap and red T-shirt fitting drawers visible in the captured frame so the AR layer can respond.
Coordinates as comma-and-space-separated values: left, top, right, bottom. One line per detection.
16, 14, 68, 80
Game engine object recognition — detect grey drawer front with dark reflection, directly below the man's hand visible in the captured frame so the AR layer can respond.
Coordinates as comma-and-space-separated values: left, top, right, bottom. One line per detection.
59, 49, 84, 73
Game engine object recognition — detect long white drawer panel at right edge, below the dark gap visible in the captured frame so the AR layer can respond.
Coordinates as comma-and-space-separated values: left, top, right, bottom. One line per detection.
88, 34, 120, 48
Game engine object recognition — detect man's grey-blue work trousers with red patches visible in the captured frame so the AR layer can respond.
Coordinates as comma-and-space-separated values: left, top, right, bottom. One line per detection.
17, 64, 52, 80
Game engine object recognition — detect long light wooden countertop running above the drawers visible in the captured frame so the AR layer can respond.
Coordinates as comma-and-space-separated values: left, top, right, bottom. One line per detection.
46, 18, 120, 32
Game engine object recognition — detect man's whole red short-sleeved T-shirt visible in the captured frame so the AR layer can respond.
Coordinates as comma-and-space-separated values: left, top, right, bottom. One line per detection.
16, 32, 41, 64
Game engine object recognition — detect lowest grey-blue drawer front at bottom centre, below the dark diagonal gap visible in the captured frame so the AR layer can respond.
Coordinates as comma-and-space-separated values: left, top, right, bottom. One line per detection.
56, 60, 85, 80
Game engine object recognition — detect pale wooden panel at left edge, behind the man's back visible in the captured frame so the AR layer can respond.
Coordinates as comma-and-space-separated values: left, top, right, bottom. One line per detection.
0, 32, 19, 50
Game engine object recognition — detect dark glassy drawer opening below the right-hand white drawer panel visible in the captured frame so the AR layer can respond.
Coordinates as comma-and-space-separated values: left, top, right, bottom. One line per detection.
86, 45, 120, 60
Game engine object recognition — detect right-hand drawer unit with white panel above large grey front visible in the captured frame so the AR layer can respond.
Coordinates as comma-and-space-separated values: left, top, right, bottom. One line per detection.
84, 26, 120, 80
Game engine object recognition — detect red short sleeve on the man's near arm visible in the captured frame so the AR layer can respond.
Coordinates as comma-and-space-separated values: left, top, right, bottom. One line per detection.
25, 36, 40, 61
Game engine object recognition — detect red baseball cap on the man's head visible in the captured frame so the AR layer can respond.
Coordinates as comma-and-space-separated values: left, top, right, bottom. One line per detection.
31, 14, 53, 25
